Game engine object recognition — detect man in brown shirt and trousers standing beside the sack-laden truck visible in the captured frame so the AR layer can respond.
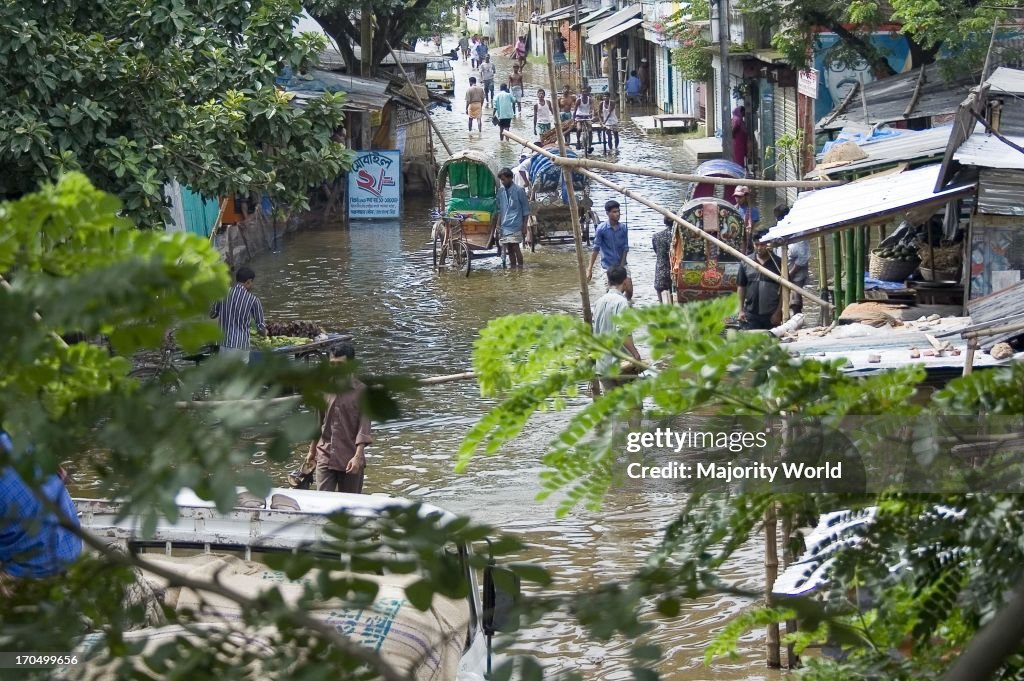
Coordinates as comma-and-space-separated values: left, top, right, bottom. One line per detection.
306, 342, 374, 494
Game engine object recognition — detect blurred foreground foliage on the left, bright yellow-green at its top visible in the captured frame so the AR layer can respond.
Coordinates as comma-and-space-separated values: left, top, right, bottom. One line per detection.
0, 174, 547, 681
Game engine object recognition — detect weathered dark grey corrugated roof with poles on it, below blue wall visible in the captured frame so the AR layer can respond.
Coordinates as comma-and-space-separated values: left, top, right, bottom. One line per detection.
817, 63, 978, 130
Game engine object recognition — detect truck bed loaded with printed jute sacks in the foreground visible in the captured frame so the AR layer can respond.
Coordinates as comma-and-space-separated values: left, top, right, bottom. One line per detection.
75, 488, 517, 681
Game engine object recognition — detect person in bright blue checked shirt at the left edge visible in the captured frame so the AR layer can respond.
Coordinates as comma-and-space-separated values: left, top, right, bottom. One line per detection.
0, 430, 82, 579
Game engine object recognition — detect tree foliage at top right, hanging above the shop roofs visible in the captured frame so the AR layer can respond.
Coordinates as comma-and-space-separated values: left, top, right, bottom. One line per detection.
738, 0, 1015, 78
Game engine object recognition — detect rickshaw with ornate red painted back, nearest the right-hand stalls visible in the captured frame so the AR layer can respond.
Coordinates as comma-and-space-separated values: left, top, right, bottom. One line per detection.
670, 160, 752, 303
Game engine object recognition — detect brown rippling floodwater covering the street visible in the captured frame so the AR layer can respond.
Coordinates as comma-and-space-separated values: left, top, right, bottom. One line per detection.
251, 57, 778, 681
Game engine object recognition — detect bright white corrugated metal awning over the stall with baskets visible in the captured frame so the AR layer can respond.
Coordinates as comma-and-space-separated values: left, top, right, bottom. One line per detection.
762, 164, 975, 245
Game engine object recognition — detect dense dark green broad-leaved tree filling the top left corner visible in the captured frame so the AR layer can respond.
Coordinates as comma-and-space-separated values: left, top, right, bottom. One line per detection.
0, 0, 349, 226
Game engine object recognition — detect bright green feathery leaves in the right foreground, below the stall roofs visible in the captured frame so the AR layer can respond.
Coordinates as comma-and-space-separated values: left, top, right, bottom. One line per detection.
459, 299, 1024, 680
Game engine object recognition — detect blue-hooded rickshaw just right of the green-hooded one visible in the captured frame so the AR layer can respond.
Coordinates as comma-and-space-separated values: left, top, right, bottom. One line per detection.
526, 146, 598, 247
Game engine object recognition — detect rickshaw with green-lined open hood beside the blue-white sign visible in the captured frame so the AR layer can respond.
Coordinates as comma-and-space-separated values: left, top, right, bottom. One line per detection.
433, 150, 504, 276
